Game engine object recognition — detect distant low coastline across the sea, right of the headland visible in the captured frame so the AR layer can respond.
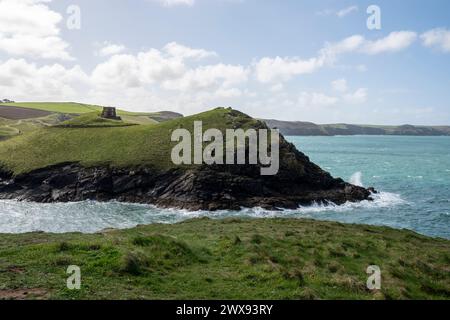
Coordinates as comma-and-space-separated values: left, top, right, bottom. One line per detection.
263, 119, 450, 136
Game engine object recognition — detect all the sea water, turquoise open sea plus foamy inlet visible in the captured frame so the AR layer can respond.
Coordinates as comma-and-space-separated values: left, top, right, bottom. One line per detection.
0, 136, 450, 239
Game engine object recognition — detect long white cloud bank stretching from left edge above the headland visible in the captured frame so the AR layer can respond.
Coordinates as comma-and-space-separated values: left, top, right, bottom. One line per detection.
0, 29, 422, 116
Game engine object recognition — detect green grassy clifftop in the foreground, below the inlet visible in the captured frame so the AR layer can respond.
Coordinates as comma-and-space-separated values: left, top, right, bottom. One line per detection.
0, 219, 450, 299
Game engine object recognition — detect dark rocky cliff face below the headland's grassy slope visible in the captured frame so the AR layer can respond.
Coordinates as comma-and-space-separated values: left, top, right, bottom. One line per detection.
0, 131, 370, 210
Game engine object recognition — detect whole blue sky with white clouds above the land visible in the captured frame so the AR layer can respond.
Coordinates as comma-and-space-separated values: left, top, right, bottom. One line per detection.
0, 0, 450, 125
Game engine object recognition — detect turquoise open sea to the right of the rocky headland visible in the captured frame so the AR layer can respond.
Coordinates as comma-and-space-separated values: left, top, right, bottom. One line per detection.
289, 136, 450, 238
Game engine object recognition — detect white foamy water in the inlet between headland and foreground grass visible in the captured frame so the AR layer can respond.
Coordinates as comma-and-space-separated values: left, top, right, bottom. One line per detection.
0, 192, 405, 233
